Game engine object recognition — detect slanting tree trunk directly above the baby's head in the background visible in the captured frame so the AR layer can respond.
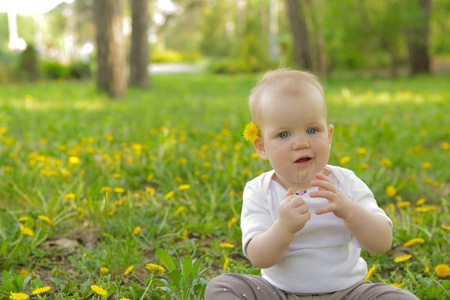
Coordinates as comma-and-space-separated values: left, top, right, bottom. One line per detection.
286, 0, 312, 70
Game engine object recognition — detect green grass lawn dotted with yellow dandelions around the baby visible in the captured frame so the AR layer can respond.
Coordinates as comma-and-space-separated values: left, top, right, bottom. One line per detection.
0, 74, 450, 299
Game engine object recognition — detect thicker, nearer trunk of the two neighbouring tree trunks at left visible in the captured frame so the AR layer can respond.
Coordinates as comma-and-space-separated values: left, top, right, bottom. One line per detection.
94, 0, 127, 98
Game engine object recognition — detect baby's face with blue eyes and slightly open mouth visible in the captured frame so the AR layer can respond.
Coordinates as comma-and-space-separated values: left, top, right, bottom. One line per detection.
255, 84, 333, 189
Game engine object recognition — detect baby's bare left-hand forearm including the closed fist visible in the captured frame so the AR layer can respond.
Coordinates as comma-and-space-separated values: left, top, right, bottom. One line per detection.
246, 189, 311, 268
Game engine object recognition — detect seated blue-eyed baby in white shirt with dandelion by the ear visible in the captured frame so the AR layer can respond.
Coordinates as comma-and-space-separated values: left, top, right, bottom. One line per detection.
205, 69, 418, 300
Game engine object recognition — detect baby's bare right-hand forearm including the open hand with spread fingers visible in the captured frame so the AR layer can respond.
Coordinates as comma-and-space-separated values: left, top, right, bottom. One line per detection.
310, 174, 392, 254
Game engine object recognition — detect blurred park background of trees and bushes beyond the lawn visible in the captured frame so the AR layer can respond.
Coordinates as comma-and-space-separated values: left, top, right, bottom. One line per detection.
0, 0, 450, 97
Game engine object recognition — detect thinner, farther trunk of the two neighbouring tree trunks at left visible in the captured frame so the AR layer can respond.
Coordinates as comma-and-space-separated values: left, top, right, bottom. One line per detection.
130, 0, 149, 88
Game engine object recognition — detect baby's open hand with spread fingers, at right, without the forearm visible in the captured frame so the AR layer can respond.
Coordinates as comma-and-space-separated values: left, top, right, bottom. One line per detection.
309, 173, 353, 219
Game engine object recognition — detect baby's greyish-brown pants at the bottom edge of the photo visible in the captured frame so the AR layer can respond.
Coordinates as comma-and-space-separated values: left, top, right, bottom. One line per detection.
205, 273, 419, 300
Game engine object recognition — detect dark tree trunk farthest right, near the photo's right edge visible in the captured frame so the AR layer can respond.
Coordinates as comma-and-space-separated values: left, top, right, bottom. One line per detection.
406, 0, 431, 75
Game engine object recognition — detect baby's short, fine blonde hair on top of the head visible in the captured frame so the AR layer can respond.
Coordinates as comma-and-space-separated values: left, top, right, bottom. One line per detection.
248, 69, 328, 126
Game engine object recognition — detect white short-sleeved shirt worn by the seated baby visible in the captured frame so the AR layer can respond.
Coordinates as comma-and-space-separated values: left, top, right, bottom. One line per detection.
241, 165, 392, 293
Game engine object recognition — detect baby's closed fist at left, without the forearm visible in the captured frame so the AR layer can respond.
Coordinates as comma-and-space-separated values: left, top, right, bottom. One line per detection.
277, 189, 311, 234
